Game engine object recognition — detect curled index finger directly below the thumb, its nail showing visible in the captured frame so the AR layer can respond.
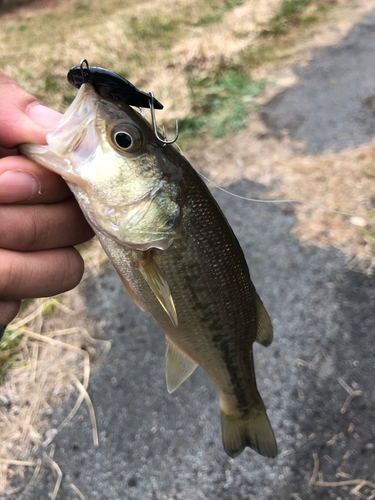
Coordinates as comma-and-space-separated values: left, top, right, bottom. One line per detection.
0, 156, 72, 204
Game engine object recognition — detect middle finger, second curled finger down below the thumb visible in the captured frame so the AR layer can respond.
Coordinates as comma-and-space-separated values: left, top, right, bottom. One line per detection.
0, 197, 94, 251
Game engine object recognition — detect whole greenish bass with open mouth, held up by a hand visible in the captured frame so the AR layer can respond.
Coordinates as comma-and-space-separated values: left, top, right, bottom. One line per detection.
20, 72, 277, 457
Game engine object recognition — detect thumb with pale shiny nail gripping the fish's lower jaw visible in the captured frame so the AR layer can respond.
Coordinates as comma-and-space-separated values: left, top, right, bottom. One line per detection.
0, 71, 61, 148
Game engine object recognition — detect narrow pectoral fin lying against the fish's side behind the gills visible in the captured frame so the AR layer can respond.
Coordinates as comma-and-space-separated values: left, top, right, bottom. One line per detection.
138, 252, 178, 326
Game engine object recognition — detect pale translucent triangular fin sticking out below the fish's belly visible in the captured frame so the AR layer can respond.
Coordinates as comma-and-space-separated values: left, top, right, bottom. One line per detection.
165, 337, 198, 393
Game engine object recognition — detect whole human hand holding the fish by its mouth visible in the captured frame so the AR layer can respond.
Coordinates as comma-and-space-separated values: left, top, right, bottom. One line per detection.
0, 71, 93, 328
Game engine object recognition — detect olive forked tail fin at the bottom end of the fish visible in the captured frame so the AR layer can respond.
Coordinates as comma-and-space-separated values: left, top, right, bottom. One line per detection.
221, 395, 277, 458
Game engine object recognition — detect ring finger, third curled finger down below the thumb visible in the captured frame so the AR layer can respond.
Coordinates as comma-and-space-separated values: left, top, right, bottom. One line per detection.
0, 247, 84, 301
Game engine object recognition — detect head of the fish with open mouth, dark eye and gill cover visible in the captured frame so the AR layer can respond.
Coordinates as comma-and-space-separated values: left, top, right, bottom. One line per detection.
20, 83, 182, 250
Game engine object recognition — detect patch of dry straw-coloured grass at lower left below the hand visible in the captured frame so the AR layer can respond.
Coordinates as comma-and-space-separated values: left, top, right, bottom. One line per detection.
0, 239, 110, 498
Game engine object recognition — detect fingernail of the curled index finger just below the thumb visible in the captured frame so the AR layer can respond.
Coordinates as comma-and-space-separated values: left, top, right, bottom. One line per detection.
0, 170, 40, 203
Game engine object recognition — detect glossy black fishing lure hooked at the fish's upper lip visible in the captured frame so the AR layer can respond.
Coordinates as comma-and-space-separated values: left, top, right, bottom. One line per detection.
67, 64, 164, 109
